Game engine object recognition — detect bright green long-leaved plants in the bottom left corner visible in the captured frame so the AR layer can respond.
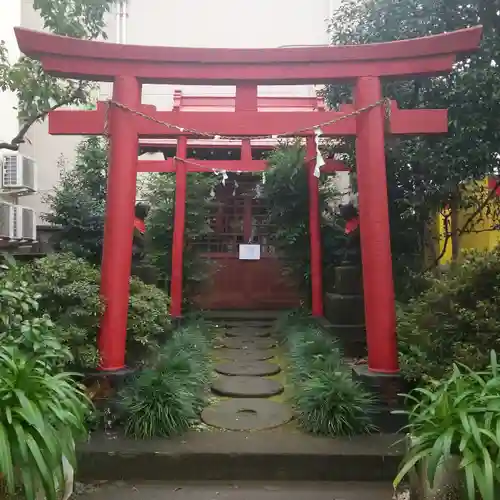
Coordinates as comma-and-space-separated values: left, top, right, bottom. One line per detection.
0, 260, 90, 500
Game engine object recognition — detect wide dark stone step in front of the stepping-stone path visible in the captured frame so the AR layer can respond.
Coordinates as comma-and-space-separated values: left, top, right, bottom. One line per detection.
77, 428, 404, 482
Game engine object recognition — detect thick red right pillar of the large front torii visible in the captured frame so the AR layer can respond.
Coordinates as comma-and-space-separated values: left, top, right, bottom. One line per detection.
354, 77, 398, 374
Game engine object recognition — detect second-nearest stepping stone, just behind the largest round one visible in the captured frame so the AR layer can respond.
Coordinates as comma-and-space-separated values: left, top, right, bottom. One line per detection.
212, 377, 284, 398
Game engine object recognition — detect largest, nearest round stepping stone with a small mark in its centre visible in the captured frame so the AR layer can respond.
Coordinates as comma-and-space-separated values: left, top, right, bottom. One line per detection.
201, 399, 292, 431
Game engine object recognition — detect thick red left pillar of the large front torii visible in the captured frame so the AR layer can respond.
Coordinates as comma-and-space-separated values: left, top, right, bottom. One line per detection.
98, 76, 141, 372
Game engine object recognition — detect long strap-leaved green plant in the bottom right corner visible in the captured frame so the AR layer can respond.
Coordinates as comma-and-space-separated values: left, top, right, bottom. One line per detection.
394, 351, 500, 500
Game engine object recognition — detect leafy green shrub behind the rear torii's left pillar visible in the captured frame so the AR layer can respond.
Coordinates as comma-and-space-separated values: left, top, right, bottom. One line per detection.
145, 173, 219, 287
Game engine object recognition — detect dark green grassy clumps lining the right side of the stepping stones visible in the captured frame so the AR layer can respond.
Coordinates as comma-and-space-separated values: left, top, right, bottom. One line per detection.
289, 327, 375, 437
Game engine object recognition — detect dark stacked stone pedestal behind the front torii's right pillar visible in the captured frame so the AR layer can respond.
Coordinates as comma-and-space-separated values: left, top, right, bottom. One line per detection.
325, 265, 366, 358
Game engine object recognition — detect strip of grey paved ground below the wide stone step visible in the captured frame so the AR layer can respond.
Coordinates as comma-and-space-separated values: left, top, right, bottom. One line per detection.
78, 482, 393, 500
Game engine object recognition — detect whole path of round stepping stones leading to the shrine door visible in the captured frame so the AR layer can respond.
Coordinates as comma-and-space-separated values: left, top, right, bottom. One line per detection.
201, 319, 292, 431
